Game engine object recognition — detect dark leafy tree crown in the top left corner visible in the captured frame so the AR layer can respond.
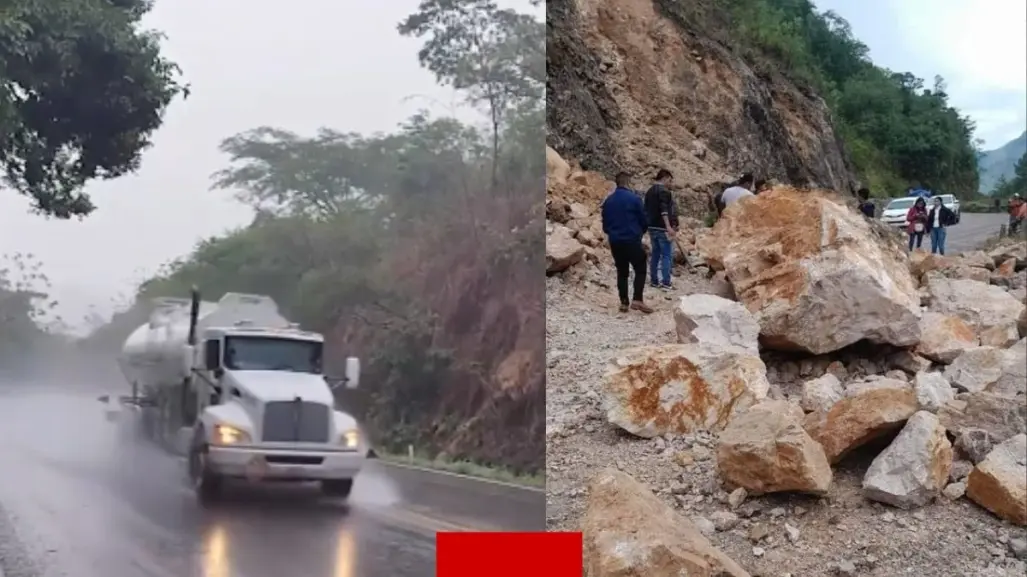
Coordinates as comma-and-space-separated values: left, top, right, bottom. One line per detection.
0, 0, 186, 219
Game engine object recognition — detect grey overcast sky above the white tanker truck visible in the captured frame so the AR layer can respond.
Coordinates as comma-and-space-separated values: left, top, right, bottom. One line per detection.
0, 0, 544, 322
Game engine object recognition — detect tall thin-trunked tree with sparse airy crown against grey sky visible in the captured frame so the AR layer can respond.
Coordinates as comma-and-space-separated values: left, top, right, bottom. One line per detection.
398, 0, 545, 188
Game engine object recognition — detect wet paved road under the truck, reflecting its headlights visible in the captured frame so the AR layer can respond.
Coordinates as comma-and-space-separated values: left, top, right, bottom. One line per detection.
0, 390, 545, 577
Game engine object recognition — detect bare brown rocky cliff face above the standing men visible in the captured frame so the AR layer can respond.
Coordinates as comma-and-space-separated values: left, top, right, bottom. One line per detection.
546, 0, 852, 216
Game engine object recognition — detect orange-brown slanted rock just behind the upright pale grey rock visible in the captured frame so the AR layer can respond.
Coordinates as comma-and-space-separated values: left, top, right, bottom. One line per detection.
804, 388, 916, 464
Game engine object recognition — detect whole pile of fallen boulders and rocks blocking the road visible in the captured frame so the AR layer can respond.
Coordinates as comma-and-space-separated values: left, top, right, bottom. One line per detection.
584, 189, 1027, 577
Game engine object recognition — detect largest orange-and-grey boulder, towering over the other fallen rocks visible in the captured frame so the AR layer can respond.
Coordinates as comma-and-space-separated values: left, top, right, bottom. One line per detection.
698, 187, 920, 354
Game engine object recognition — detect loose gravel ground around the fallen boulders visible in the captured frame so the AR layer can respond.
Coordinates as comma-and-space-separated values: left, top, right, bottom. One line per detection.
546, 263, 1027, 577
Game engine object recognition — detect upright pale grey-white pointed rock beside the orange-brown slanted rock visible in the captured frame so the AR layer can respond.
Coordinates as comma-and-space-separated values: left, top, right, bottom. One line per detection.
863, 411, 952, 509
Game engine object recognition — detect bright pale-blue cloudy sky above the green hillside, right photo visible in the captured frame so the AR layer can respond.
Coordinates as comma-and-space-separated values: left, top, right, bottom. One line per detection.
813, 0, 1027, 150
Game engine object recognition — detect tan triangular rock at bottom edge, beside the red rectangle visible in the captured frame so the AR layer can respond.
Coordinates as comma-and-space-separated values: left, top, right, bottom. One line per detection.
581, 469, 751, 577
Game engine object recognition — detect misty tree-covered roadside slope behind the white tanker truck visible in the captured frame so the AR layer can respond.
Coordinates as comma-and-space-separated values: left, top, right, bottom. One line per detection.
104, 2, 545, 471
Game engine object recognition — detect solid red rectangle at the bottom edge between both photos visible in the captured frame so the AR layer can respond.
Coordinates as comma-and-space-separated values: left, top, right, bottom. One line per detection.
435, 533, 581, 577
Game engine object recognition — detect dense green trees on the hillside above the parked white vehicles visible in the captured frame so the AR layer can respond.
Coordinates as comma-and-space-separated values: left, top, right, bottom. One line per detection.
727, 0, 979, 198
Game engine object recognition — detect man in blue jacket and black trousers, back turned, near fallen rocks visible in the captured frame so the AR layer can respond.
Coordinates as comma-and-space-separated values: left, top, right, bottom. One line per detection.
603, 172, 652, 314
